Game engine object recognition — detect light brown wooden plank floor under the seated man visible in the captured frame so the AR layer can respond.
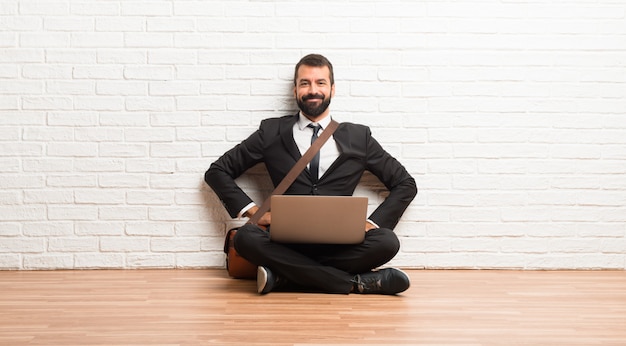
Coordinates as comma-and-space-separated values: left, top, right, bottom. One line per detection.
0, 270, 626, 345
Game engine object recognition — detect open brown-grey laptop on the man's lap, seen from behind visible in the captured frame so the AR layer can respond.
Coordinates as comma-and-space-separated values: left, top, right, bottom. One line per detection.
270, 195, 367, 244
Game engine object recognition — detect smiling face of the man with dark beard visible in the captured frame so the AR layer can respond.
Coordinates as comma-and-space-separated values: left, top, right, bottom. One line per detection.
294, 65, 335, 121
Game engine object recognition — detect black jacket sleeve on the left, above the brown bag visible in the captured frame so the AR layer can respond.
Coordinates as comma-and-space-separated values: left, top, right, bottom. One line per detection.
204, 126, 263, 218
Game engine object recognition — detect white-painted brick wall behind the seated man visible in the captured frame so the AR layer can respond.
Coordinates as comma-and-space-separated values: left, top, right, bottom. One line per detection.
0, 0, 626, 269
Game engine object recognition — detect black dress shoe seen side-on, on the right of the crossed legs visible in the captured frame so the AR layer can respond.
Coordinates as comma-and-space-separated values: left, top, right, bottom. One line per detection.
352, 268, 411, 294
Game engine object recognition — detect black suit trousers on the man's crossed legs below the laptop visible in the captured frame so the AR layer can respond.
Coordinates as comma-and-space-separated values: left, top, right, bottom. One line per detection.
233, 225, 400, 294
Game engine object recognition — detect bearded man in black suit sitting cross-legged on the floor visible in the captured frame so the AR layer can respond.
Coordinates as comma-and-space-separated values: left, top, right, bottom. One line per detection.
205, 54, 417, 294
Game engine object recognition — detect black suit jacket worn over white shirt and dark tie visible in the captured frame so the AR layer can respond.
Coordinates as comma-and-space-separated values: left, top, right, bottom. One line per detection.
204, 114, 417, 229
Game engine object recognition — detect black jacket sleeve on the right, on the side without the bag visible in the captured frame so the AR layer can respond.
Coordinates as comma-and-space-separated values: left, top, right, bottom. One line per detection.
366, 129, 417, 229
